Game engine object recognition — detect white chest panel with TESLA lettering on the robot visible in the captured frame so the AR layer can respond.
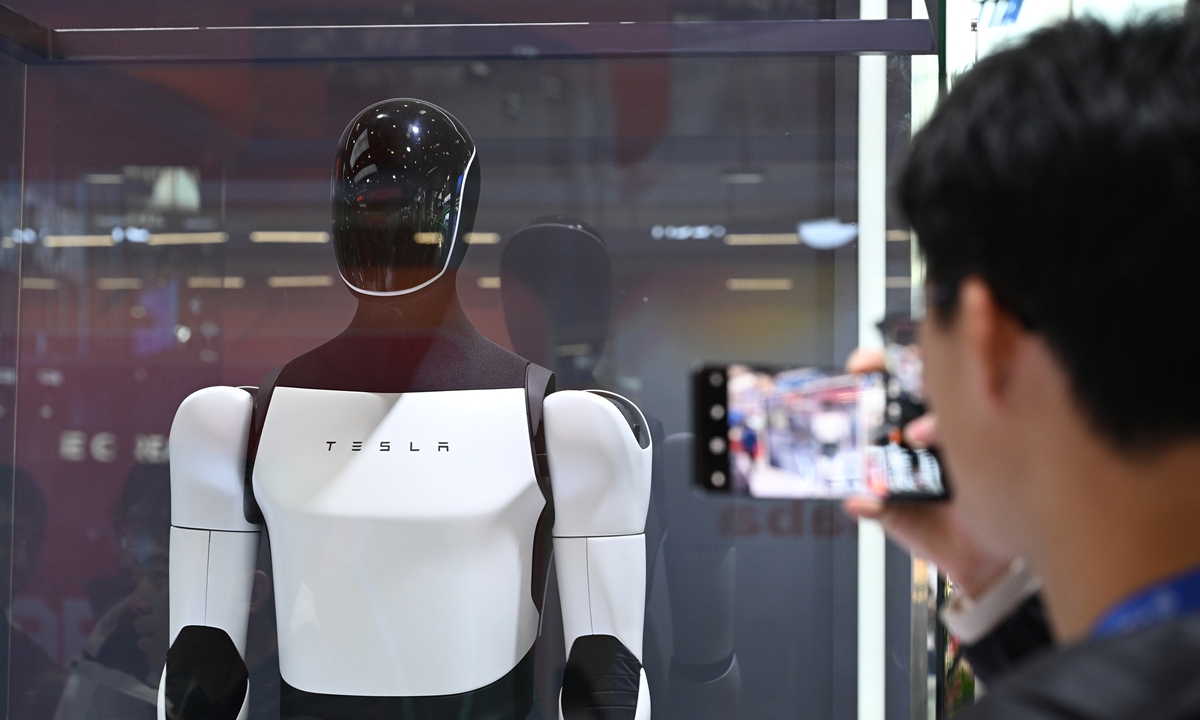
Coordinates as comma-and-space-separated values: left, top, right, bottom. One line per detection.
253, 388, 545, 697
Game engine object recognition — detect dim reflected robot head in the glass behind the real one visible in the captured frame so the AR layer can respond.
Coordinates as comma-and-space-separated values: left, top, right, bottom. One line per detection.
500, 216, 612, 388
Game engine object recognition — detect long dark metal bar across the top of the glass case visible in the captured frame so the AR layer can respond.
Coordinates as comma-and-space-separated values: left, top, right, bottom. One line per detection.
0, 13, 936, 64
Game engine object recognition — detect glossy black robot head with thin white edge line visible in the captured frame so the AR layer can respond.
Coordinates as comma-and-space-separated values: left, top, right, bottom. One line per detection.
332, 98, 479, 296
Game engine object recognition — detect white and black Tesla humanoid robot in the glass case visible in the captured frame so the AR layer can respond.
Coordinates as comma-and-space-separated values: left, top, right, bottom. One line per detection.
158, 100, 652, 720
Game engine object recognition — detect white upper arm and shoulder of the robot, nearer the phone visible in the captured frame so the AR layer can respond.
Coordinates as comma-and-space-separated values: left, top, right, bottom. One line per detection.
544, 390, 653, 538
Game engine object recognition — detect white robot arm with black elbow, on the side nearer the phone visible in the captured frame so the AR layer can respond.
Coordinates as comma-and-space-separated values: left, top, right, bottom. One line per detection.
544, 391, 652, 720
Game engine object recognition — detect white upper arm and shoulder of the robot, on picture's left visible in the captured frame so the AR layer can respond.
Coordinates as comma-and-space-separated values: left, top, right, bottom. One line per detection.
168, 388, 258, 532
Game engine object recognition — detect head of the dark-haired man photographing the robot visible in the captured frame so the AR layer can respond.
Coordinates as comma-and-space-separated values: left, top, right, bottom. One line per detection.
899, 16, 1200, 556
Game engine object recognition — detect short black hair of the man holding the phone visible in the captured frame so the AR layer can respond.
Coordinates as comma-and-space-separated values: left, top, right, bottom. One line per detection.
898, 18, 1200, 450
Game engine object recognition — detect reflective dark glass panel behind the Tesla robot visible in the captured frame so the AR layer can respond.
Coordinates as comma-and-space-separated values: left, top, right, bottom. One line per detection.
0, 14, 916, 719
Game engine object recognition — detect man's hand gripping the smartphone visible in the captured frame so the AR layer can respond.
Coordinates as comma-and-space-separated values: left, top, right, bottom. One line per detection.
844, 348, 1014, 598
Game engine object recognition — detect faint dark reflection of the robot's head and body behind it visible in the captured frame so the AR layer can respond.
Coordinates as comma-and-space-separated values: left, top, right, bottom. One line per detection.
500, 216, 742, 720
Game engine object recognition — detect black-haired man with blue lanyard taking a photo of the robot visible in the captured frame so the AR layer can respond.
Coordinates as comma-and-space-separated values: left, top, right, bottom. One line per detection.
854, 14, 1200, 718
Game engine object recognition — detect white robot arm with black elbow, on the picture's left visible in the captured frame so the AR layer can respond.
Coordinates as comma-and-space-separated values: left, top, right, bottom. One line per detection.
158, 388, 260, 720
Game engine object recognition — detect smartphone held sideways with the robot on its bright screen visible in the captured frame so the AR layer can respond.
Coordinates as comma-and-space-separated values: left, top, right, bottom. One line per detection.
692, 362, 949, 502
